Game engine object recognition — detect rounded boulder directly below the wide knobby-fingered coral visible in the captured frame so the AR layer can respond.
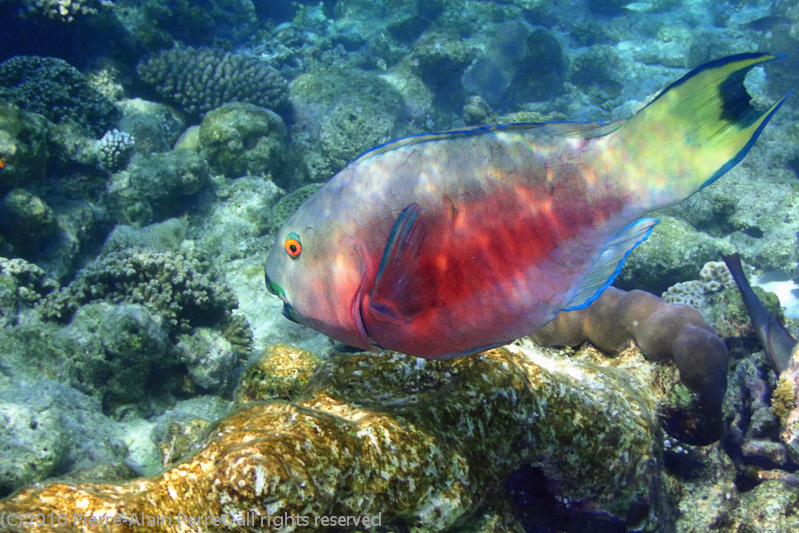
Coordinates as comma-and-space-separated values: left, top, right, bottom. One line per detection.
200, 102, 297, 187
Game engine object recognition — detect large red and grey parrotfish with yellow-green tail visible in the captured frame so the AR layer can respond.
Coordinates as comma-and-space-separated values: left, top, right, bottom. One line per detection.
266, 53, 787, 358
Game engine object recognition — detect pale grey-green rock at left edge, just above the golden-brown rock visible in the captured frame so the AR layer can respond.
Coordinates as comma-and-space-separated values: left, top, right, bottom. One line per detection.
0, 380, 128, 496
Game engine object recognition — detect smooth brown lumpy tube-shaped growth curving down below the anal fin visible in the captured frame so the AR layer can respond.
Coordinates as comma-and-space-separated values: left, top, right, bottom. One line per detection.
532, 287, 729, 445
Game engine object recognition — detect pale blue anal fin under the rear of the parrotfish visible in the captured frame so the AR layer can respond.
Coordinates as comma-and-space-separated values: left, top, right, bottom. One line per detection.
563, 218, 660, 311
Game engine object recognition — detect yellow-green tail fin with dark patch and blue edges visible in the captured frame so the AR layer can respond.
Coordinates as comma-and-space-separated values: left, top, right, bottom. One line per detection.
619, 53, 790, 197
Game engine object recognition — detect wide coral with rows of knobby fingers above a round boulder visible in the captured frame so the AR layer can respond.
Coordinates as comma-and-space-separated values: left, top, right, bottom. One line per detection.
138, 48, 288, 119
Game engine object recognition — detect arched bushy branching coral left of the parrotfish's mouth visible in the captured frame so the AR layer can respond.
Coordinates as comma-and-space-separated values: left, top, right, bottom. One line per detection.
37, 249, 237, 333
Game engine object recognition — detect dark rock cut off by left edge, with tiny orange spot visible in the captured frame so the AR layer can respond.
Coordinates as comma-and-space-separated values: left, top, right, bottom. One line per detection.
0, 101, 49, 192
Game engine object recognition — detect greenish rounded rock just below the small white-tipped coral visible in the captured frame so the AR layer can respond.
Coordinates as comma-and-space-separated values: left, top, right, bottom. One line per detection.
103, 150, 210, 226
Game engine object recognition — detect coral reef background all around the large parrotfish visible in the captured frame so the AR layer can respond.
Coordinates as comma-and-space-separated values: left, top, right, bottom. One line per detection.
0, 0, 799, 532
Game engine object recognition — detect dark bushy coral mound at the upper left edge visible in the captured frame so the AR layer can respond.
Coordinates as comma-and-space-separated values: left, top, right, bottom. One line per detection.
0, 56, 119, 135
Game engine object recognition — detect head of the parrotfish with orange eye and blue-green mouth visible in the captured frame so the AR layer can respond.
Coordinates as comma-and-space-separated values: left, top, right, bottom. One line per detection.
265, 190, 371, 349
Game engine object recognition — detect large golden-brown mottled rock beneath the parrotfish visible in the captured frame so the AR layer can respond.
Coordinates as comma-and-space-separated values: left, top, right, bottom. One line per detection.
0, 347, 662, 532
